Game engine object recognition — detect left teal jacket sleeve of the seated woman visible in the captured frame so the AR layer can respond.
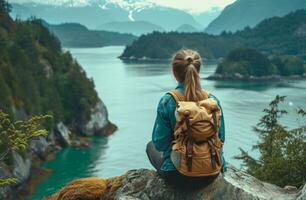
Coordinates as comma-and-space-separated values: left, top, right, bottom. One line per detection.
152, 94, 173, 152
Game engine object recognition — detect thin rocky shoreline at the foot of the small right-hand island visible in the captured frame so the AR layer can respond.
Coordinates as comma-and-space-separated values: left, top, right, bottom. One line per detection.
205, 73, 306, 81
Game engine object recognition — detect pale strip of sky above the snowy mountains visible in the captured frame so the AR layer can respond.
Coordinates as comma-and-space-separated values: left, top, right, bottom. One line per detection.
9, 0, 235, 13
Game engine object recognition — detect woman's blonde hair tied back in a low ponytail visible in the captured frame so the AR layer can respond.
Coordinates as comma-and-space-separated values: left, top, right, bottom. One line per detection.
172, 49, 205, 101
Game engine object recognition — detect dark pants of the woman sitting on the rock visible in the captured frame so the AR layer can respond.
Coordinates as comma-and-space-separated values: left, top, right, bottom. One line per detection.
146, 141, 218, 189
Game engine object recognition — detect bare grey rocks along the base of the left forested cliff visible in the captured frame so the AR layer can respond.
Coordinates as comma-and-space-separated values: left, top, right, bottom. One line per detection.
0, 101, 117, 200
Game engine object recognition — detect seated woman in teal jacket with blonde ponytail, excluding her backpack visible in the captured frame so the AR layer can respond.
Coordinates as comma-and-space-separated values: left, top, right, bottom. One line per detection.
146, 49, 226, 185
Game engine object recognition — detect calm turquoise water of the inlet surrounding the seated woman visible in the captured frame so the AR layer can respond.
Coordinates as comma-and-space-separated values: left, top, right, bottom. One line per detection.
29, 47, 306, 200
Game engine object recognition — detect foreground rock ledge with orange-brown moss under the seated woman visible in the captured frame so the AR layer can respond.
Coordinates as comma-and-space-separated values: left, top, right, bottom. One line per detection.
46, 166, 306, 200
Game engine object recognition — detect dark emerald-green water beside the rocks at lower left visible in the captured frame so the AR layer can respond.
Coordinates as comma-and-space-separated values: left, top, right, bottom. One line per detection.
29, 137, 108, 200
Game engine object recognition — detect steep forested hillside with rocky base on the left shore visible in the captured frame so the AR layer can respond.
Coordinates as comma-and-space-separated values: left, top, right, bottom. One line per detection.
0, 3, 115, 200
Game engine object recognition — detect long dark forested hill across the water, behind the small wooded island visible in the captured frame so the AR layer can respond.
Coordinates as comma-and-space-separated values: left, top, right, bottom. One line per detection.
121, 10, 306, 60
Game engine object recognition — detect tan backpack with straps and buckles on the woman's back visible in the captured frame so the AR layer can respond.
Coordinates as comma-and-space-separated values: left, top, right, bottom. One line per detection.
169, 90, 223, 177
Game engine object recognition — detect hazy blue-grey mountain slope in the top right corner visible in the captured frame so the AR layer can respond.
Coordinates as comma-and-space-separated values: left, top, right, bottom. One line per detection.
205, 0, 306, 34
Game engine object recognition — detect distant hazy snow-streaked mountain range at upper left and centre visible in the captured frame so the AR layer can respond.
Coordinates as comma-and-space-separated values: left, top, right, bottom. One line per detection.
11, 0, 201, 31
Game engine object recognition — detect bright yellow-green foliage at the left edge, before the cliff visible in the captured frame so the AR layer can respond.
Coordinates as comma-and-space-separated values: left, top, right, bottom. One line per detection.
0, 110, 51, 187
